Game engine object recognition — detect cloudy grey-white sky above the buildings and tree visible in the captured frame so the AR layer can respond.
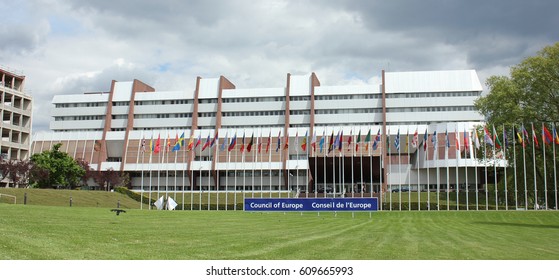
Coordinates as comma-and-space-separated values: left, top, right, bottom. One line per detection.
0, 0, 559, 131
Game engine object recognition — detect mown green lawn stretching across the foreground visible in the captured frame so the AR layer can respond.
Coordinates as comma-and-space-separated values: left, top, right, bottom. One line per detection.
0, 203, 559, 260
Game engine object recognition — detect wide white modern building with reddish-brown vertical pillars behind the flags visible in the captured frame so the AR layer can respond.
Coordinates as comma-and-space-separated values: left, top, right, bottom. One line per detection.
30, 70, 483, 200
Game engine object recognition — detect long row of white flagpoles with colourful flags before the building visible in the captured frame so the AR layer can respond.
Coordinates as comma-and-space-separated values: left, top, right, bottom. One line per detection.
130, 121, 559, 210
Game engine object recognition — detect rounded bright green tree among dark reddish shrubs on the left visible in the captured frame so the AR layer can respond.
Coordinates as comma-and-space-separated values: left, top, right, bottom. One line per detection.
30, 143, 85, 188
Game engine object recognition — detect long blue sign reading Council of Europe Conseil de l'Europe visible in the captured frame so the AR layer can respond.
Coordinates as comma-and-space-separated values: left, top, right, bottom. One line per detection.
245, 197, 378, 212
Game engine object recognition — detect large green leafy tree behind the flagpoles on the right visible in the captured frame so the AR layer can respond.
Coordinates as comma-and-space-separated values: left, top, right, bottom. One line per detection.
474, 43, 559, 207
